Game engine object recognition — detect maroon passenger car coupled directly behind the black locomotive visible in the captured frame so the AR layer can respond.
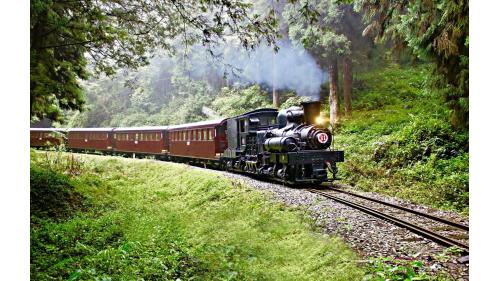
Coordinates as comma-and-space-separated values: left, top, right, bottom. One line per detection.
169, 119, 227, 160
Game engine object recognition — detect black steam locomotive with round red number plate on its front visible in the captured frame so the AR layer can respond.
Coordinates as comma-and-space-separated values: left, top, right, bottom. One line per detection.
221, 102, 344, 184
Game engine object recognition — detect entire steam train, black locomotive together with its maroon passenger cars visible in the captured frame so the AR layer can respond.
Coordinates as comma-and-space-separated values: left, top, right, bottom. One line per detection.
30, 102, 344, 184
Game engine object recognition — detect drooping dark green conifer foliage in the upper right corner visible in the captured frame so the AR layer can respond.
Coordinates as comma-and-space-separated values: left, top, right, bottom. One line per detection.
355, 0, 469, 128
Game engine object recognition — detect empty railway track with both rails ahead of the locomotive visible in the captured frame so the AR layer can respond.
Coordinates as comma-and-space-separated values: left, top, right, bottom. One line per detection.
308, 188, 469, 254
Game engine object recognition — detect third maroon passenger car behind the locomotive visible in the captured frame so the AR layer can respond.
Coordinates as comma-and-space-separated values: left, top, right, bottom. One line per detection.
68, 128, 113, 151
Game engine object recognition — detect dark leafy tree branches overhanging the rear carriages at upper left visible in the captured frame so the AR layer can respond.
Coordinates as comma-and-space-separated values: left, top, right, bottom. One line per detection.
30, 0, 277, 120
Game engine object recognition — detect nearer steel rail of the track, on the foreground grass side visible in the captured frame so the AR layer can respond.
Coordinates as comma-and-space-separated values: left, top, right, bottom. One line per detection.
308, 189, 469, 253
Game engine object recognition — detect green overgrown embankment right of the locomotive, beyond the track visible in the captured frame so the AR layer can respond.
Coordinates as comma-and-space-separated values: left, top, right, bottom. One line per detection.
335, 63, 469, 214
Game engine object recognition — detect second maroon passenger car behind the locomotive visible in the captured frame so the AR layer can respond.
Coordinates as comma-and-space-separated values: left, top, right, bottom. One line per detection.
113, 126, 169, 155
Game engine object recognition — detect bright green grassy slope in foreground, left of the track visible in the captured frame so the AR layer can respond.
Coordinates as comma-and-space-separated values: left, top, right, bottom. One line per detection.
30, 153, 365, 280
